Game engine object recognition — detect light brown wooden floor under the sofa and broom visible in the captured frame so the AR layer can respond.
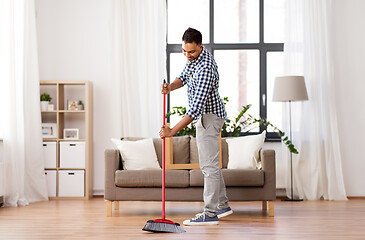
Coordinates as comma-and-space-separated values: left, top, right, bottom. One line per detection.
0, 197, 365, 240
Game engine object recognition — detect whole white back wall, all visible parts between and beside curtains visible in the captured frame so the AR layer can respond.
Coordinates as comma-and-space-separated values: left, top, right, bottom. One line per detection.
36, 0, 365, 196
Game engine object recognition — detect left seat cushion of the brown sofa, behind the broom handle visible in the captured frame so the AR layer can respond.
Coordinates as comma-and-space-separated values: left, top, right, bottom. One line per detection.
115, 169, 189, 187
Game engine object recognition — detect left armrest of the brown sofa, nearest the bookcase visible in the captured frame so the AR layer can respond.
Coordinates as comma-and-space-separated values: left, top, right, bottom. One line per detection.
104, 149, 120, 201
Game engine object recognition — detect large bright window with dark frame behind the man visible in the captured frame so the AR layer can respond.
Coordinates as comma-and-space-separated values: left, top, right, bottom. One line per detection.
167, 0, 285, 139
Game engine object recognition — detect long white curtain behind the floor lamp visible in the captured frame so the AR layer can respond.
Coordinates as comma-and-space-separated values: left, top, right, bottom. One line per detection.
283, 0, 347, 200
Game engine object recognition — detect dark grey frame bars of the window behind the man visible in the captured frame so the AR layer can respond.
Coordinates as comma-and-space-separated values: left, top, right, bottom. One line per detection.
166, 0, 284, 142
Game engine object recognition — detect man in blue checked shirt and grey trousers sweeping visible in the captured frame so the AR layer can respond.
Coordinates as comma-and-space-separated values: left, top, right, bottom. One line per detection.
160, 28, 233, 225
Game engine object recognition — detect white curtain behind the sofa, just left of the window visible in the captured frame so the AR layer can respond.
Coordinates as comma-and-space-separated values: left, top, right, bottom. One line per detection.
109, 0, 166, 137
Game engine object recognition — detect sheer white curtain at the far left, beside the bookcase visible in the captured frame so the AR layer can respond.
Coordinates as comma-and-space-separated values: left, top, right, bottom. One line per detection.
0, 0, 48, 206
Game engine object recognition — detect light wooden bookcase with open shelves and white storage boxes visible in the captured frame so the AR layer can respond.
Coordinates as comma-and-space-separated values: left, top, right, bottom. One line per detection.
40, 81, 93, 199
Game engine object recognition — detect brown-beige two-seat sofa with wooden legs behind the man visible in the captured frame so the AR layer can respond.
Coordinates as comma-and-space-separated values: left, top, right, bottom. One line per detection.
104, 136, 276, 216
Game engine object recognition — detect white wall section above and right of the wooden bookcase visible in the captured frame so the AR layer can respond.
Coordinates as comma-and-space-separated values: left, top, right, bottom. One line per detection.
36, 0, 118, 194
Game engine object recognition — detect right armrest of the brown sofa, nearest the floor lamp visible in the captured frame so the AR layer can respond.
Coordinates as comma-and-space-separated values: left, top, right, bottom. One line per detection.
260, 149, 276, 201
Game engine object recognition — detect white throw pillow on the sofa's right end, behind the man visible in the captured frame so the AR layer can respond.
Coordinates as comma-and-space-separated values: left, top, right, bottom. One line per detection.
226, 131, 266, 169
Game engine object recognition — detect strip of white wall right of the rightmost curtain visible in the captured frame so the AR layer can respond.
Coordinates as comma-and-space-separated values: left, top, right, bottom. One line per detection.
333, 0, 365, 196
